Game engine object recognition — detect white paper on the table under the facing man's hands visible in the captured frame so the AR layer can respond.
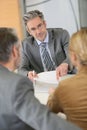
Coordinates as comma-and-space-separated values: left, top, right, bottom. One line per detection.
34, 71, 73, 93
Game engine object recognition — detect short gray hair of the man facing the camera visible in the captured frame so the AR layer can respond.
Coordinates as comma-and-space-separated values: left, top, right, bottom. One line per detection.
23, 10, 44, 25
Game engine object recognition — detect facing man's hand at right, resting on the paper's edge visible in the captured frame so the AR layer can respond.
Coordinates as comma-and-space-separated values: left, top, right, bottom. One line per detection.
56, 63, 68, 79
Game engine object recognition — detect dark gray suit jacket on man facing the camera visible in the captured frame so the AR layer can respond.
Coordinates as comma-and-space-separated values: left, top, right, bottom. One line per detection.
19, 28, 73, 75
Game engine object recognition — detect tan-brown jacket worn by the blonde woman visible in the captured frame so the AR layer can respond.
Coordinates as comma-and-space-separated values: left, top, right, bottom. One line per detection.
47, 67, 87, 130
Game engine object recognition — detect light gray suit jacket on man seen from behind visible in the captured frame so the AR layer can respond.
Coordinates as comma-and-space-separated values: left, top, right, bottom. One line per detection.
0, 65, 80, 130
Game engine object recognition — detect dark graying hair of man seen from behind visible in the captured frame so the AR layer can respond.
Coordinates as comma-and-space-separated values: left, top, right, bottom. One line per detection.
0, 27, 18, 63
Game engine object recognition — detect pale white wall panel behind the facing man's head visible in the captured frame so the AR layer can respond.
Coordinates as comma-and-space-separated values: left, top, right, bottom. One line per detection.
26, 0, 80, 35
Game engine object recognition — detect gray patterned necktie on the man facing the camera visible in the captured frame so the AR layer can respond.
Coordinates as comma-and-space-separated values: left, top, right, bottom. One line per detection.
40, 43, 55, 71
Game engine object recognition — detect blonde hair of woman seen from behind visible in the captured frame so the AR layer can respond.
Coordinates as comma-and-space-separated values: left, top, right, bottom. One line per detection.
69, 29, 87, 65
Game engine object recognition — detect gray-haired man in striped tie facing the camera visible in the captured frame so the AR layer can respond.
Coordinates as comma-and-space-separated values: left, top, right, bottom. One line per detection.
19, 10, 75, 81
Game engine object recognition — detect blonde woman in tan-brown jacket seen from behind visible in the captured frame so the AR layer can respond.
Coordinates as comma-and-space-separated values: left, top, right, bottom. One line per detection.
47, 29, 87, 130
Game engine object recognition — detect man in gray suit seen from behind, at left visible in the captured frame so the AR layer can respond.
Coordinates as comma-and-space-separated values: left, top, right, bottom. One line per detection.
0, 28, 80, 130
